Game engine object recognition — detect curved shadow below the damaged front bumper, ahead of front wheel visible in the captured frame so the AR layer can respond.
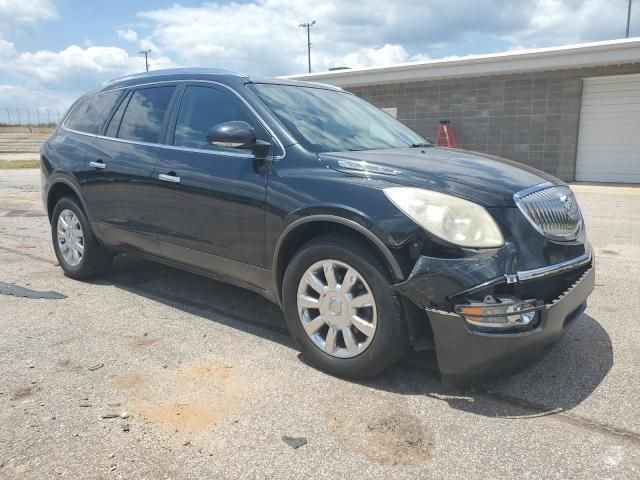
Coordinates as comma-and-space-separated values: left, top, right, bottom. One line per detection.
352, 315, 613, 418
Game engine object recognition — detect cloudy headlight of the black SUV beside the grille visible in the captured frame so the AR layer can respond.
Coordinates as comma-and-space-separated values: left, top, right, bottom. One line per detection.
384, 187, 504, 248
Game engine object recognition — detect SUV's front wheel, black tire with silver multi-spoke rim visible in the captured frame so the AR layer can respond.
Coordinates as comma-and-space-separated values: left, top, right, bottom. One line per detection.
282, 235, 408, 378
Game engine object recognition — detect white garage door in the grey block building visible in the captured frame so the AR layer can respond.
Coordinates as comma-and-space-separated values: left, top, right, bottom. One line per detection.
576, 75, 640, 183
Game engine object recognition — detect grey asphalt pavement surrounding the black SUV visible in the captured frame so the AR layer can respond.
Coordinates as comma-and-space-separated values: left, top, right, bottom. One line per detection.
0, 170, 640, 479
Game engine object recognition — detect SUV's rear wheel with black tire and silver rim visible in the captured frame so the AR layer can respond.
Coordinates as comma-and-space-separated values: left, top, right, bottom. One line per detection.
51, 196, 113, 280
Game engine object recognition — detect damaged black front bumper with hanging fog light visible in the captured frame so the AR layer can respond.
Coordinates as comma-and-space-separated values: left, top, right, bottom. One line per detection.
395, 244, 595, 385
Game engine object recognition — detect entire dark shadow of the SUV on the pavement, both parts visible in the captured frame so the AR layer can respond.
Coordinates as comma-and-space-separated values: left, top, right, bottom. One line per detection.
95, 255, 613, 418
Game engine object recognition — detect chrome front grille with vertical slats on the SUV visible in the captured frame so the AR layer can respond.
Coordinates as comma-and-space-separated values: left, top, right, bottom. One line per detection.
513, 184, 582, 240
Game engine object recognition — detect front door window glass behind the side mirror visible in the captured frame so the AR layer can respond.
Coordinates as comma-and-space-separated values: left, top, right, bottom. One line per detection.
173, 86, 255, 152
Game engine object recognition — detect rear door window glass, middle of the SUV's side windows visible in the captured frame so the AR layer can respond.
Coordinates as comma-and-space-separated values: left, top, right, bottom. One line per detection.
118, 86, 175, 143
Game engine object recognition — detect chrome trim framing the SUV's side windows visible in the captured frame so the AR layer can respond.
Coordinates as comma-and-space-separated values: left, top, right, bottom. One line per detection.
61, 79, 287, 160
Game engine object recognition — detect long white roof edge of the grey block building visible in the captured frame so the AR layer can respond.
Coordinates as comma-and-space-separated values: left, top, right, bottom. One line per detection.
286, 37, 640, 87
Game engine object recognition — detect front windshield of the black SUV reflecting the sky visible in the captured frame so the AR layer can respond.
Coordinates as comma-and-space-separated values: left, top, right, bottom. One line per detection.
248, 84, 428, 153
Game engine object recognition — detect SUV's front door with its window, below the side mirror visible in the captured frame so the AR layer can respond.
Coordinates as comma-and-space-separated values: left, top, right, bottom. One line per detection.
156, 84, 271, 283
